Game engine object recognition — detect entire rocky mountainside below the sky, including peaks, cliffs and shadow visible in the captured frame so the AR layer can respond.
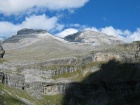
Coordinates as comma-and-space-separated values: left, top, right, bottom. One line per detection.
0, 29, 140, 105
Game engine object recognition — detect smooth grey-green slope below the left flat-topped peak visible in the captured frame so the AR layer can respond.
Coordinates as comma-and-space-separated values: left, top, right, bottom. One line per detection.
3, 38, 93, 63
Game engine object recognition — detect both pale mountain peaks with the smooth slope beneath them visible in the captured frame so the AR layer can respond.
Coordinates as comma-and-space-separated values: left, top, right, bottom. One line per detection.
2, 29, 122, 63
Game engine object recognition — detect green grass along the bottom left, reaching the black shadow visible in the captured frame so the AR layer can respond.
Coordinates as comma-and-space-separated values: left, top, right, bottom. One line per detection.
0, 83, 63, 105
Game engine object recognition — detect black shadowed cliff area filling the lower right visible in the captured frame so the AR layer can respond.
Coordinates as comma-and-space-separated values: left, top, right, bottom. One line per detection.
62, 60, 140, 105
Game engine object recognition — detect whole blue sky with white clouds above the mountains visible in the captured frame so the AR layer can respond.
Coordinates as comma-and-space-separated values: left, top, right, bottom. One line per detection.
0, 0, 140, 42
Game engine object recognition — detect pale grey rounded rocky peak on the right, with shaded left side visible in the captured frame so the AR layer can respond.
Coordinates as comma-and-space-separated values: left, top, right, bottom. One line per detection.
64, 31, 123, 46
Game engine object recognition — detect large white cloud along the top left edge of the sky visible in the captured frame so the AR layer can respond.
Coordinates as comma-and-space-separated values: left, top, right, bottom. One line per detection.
0, 0, 89, 15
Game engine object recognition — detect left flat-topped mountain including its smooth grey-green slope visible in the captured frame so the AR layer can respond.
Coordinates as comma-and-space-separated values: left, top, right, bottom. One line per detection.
3, 29, 88, 63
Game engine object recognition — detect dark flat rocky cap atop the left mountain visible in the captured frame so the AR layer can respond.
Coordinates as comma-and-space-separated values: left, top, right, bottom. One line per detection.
17, 28, 47, 35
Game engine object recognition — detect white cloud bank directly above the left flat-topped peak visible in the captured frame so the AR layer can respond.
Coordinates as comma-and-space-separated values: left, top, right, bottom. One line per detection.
0, 15, 63, 37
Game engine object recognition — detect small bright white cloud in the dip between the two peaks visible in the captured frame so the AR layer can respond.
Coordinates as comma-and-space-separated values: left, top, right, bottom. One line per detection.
56, 28, 78, 38
